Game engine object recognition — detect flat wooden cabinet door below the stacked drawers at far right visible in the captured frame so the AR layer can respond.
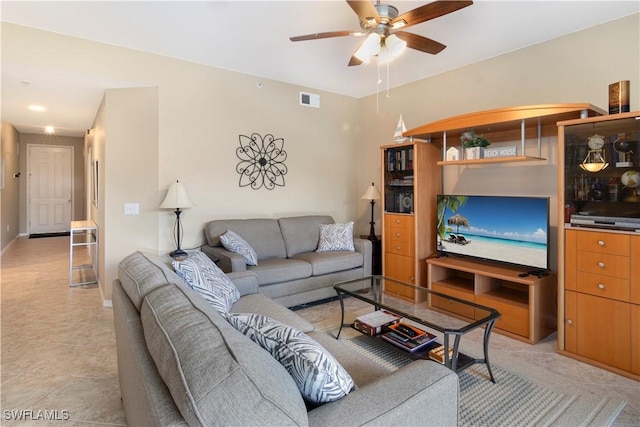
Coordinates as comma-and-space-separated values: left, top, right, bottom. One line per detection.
576, 294, 631, 371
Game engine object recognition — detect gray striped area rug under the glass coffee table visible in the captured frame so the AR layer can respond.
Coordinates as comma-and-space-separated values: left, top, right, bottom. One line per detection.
342, 335, 626, 426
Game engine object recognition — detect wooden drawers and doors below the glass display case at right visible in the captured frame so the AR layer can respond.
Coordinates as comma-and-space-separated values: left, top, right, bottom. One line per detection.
559, 228, 640, 379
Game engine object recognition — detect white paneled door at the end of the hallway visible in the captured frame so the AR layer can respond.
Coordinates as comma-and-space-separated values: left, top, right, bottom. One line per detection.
28, 145, 73, 234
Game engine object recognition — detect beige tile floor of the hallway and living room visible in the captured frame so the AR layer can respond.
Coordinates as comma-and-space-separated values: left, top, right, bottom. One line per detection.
0, 237, 640, 426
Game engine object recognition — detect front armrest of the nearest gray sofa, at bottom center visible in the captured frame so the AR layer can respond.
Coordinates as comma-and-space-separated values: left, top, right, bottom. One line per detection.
308, 360, 459, 426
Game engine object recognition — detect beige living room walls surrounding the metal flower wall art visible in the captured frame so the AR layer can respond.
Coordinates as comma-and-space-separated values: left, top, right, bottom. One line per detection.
2, 15, 640, 298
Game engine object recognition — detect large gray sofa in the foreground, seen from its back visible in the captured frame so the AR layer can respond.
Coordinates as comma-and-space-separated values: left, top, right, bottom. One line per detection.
113, 252, 458, 426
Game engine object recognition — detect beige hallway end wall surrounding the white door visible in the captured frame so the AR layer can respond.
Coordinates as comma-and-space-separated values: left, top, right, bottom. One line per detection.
15, 133, 86, 235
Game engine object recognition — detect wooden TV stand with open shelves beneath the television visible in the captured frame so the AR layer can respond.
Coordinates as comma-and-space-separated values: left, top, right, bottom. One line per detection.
427, 256, 557, 344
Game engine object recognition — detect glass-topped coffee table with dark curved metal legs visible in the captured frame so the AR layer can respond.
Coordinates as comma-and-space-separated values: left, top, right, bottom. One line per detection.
334, 276, 500, 383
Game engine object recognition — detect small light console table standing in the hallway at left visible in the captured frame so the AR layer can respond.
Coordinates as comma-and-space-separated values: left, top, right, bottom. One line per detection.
69, 221, 98, 286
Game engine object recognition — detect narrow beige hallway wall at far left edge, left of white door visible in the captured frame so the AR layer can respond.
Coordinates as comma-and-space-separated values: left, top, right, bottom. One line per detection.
0, 123, 19, 251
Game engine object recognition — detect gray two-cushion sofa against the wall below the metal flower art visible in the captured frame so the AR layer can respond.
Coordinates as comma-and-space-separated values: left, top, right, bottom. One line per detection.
202, 215, 372, 307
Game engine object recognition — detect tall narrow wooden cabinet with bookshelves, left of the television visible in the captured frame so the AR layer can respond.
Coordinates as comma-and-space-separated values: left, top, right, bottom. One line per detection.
381, 141, 441, 301
